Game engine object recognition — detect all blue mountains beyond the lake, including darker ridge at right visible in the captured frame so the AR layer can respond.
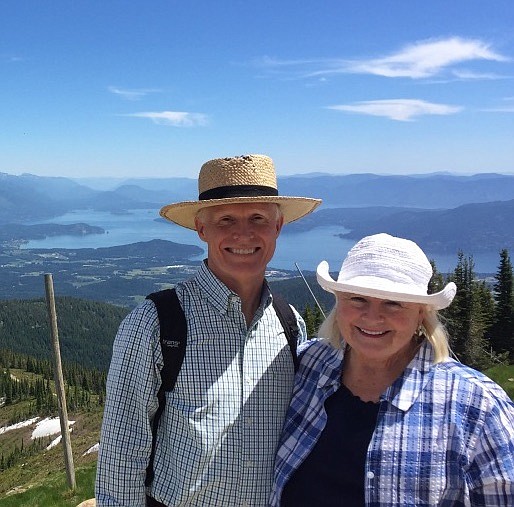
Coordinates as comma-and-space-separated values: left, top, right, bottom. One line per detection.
0, 173, 514, 253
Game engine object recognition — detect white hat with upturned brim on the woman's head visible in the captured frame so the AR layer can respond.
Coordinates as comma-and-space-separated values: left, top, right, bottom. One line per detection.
316, 233, 457, 310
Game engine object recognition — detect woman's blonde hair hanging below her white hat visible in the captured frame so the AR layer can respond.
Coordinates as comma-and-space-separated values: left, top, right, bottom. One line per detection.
318, 303, 450, 363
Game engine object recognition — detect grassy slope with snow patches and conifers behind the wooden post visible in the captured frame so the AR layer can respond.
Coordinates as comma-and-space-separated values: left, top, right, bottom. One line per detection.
0, 348, 106, 505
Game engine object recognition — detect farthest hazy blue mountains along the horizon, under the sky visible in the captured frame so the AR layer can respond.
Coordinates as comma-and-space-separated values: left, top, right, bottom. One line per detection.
0, 173, 514, 222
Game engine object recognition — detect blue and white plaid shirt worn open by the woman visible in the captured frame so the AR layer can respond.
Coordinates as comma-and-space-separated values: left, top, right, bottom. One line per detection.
270, 341, 514, 507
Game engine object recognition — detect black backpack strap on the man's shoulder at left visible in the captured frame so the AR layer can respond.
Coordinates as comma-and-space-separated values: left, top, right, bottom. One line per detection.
145, 289, 187, 486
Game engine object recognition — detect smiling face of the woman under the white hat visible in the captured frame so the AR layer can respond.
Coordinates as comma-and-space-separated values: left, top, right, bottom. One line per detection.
337, 292, 424, 363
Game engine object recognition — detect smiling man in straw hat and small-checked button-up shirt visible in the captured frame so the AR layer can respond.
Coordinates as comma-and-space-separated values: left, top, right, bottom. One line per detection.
96, 155, 321, 507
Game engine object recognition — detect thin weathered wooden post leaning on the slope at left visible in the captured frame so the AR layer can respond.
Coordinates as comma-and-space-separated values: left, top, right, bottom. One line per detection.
45, 274, 76, 490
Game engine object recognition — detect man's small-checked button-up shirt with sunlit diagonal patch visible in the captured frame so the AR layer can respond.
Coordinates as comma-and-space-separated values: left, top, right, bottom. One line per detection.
96, 263, 306, 507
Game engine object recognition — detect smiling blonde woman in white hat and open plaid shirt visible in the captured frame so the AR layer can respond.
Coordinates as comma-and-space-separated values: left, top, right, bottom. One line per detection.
270, 234, 514, 507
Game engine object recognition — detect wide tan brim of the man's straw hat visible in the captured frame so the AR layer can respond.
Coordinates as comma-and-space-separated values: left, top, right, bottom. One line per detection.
159, 196, 321, 230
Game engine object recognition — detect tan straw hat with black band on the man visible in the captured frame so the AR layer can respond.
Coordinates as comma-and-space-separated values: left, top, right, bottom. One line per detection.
160, 155, 321, 230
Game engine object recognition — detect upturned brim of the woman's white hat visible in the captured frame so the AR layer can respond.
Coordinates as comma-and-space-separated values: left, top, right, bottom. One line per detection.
316, 261, 457, 310
